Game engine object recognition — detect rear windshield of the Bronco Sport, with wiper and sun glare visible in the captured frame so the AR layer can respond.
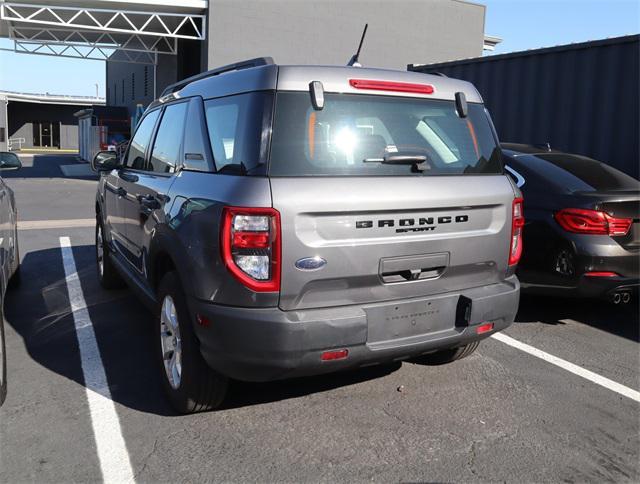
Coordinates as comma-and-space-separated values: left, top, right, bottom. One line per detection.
269, 92, 502, 176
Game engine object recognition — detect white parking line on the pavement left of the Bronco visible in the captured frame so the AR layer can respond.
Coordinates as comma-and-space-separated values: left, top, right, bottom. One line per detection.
60, 237, 135, 483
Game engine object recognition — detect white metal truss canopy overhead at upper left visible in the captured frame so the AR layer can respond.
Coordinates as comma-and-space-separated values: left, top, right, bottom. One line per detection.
0, 0, 208, 64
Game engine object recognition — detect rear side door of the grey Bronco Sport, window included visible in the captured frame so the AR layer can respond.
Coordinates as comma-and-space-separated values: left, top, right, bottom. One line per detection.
124, 100, 189, 273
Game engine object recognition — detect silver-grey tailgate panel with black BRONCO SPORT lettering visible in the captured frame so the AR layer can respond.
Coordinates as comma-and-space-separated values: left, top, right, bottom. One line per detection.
271, 175, 514, 310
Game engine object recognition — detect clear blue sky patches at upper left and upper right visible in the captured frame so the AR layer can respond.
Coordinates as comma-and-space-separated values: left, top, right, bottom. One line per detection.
0, 0, 640, 96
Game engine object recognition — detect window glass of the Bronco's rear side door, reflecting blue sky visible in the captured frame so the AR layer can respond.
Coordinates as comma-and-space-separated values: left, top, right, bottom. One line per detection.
149, 102, 189, 173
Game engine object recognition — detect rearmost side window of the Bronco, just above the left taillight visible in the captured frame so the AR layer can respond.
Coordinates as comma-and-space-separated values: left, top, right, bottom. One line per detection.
205, 92, 271, 174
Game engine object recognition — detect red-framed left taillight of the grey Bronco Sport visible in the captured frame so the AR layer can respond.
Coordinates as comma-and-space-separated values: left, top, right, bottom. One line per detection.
220, 207, 280, 292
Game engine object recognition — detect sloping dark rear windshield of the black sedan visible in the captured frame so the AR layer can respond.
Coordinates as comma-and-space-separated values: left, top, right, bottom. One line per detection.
535, 153, 638, 191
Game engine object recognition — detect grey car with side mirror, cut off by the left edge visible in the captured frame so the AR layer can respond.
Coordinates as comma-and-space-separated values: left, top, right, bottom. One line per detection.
0, 152, 22, 405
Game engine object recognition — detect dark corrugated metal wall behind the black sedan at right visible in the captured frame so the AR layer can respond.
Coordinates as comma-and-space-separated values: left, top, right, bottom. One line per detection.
409, 35, 640, 178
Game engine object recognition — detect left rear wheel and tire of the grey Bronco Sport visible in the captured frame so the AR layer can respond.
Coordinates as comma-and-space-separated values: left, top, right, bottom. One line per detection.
154, 272, 229, 414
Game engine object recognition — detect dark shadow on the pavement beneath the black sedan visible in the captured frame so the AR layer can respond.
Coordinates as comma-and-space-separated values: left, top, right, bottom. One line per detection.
516, 294, 640, 342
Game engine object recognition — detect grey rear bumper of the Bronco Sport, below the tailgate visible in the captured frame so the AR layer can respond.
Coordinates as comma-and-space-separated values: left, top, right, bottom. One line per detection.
189, 276, 520, 381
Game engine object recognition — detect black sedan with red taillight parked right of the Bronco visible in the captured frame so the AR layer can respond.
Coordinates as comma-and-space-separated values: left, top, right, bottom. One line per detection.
502, 144, 640, 304
